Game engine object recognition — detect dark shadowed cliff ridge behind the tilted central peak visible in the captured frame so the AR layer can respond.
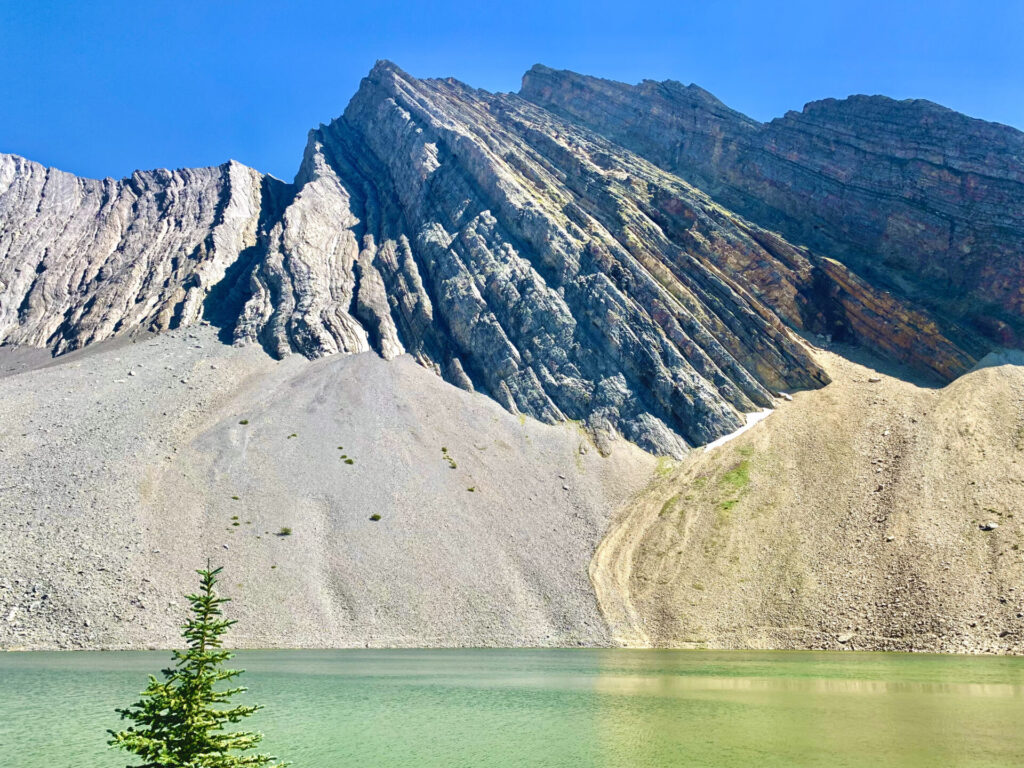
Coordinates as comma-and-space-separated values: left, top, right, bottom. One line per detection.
521, 67, 1024, 344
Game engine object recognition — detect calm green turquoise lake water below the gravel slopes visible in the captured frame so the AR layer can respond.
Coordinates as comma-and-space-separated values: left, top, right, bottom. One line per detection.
0, 649, 1024, 768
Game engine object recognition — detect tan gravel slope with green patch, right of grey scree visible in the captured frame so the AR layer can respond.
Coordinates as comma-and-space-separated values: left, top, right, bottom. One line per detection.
591, 349, 1024, 653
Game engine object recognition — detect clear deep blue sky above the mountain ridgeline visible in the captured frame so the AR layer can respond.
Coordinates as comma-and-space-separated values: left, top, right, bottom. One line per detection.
0, 0, 1024, 180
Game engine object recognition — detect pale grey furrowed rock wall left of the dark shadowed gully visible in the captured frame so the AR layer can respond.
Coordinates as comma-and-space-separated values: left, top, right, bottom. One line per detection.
0, 155, 270, 353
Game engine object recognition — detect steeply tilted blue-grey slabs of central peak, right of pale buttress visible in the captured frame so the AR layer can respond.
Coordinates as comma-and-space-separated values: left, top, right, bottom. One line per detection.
312, 66, 839, 453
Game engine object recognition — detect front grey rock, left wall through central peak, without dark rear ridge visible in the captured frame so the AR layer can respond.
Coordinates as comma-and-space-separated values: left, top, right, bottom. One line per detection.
0, 62, 991, 456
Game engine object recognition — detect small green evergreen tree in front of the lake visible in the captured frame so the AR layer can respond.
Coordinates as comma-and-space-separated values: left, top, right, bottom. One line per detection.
108, 567, 287, 768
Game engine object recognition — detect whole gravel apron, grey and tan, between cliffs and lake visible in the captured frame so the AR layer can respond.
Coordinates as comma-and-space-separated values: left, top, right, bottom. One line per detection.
8, 328, 1024, 652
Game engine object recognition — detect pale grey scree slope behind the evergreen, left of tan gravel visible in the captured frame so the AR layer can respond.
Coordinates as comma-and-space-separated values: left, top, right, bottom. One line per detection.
0, 328, 653, 648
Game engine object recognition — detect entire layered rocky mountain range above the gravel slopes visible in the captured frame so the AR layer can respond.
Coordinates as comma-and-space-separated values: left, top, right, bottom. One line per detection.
0, 61, 1024, 457
